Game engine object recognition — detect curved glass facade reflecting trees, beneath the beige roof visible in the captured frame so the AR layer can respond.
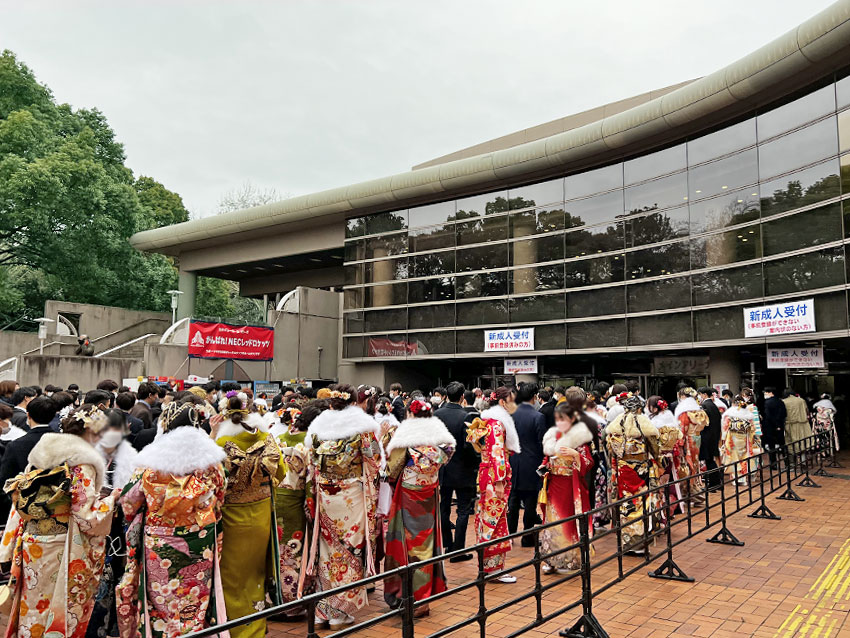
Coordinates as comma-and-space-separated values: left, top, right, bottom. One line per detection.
343, 78, 850, 359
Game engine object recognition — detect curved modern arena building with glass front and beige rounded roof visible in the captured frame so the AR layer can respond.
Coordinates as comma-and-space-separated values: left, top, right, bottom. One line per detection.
132, 1, 850, 400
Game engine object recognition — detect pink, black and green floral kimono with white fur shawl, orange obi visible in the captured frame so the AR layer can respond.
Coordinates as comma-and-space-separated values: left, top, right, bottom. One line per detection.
116, 425, 227, 638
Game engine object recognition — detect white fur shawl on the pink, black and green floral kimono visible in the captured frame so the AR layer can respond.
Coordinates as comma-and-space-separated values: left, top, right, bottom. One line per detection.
134, 425, 226, 476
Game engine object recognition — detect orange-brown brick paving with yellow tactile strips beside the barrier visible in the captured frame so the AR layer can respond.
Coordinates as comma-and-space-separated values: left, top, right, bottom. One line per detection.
269, 455, 850, 638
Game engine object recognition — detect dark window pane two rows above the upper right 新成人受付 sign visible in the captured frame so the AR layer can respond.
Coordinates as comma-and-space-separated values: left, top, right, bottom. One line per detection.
761, 203, 843, 257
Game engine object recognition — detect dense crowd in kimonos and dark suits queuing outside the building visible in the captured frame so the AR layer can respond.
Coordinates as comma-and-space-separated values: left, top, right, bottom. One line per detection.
0, 380, 838, 638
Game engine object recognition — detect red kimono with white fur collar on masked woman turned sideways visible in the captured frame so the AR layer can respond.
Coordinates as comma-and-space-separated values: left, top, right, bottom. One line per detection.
540, 421, 593, 570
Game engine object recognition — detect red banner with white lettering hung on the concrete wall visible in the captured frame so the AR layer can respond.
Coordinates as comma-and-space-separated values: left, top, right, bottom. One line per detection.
189, 319, 274, 361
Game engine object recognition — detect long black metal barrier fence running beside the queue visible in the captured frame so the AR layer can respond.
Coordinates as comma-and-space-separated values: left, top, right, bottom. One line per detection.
181, 431, 841, 638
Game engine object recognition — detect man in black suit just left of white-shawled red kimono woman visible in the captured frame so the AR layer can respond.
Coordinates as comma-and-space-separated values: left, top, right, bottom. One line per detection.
434, 381, 481, 563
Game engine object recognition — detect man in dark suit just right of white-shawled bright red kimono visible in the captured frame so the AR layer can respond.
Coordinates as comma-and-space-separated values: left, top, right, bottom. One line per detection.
508, 383, 549, 547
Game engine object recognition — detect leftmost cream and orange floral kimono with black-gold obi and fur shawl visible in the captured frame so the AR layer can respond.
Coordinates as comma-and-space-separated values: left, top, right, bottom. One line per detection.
0, 433, 115, 638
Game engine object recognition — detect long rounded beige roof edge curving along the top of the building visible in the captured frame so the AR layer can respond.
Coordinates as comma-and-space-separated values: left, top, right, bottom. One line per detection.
130, 0, 850, 254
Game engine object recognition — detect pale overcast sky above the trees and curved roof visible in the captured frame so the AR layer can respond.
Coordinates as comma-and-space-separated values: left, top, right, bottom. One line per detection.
0, 0, 830, 216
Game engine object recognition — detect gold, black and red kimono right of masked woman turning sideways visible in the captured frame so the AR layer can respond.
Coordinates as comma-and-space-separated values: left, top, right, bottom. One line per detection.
605, 412, 660, 551
